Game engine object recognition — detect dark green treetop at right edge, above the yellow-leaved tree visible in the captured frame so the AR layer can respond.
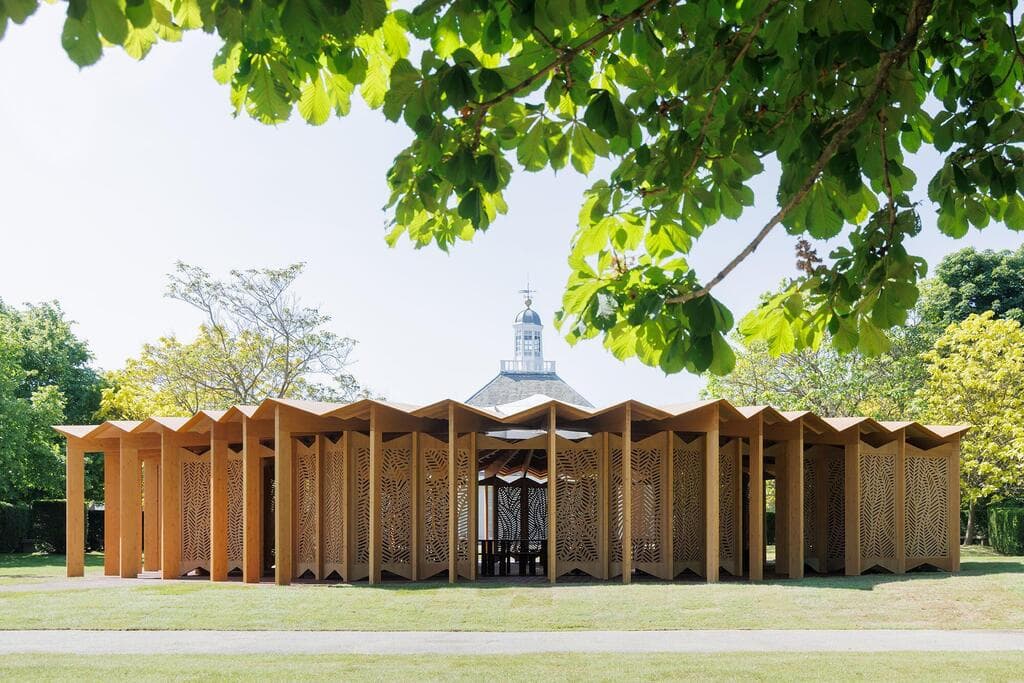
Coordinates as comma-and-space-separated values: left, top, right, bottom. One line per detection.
922, 246, 1024, 330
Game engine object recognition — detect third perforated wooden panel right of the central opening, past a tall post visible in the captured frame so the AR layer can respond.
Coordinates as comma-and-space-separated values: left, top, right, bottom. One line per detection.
631, 434, 666, 575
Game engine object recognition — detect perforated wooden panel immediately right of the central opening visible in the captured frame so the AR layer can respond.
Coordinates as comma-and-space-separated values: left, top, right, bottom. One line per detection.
555, 435, 602, 579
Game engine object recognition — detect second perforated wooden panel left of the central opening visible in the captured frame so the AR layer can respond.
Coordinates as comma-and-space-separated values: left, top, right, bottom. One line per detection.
420, 434, 449, 579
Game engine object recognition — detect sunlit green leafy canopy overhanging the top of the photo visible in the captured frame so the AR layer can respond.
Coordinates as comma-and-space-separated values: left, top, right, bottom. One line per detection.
0, 0, 1024, 374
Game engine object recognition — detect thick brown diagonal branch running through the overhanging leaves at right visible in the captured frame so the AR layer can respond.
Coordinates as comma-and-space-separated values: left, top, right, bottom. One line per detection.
666, 0, 934, 303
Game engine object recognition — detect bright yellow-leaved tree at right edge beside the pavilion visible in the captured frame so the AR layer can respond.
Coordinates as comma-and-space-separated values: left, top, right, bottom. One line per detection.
921, 311, 1024, 543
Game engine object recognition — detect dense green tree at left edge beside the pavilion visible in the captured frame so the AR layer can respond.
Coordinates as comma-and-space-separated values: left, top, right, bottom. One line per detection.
0, 302, 102, 502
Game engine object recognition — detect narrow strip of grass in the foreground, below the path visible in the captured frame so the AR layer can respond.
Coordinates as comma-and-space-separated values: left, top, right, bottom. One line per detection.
0, 652, 1024, 681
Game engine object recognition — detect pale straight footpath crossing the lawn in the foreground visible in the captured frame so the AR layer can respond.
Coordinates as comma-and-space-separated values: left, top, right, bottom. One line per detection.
0, 630, 1024, 654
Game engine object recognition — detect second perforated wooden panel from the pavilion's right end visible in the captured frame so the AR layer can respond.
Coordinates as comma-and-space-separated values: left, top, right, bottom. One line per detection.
859, 441, 898, 571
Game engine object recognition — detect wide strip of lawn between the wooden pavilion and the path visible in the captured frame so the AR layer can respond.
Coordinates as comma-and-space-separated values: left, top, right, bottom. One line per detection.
0, 549, 1024, 631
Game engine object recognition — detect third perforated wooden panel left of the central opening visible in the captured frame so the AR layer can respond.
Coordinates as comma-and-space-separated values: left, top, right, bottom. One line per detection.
380, 434, 413, 579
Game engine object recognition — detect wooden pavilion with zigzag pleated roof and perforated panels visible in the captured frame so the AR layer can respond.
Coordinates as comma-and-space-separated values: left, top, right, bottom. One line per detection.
55, 395, 967, 584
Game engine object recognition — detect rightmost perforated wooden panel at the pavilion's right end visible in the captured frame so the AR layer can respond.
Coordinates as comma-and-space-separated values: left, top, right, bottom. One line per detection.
904, 444, 959, 568
